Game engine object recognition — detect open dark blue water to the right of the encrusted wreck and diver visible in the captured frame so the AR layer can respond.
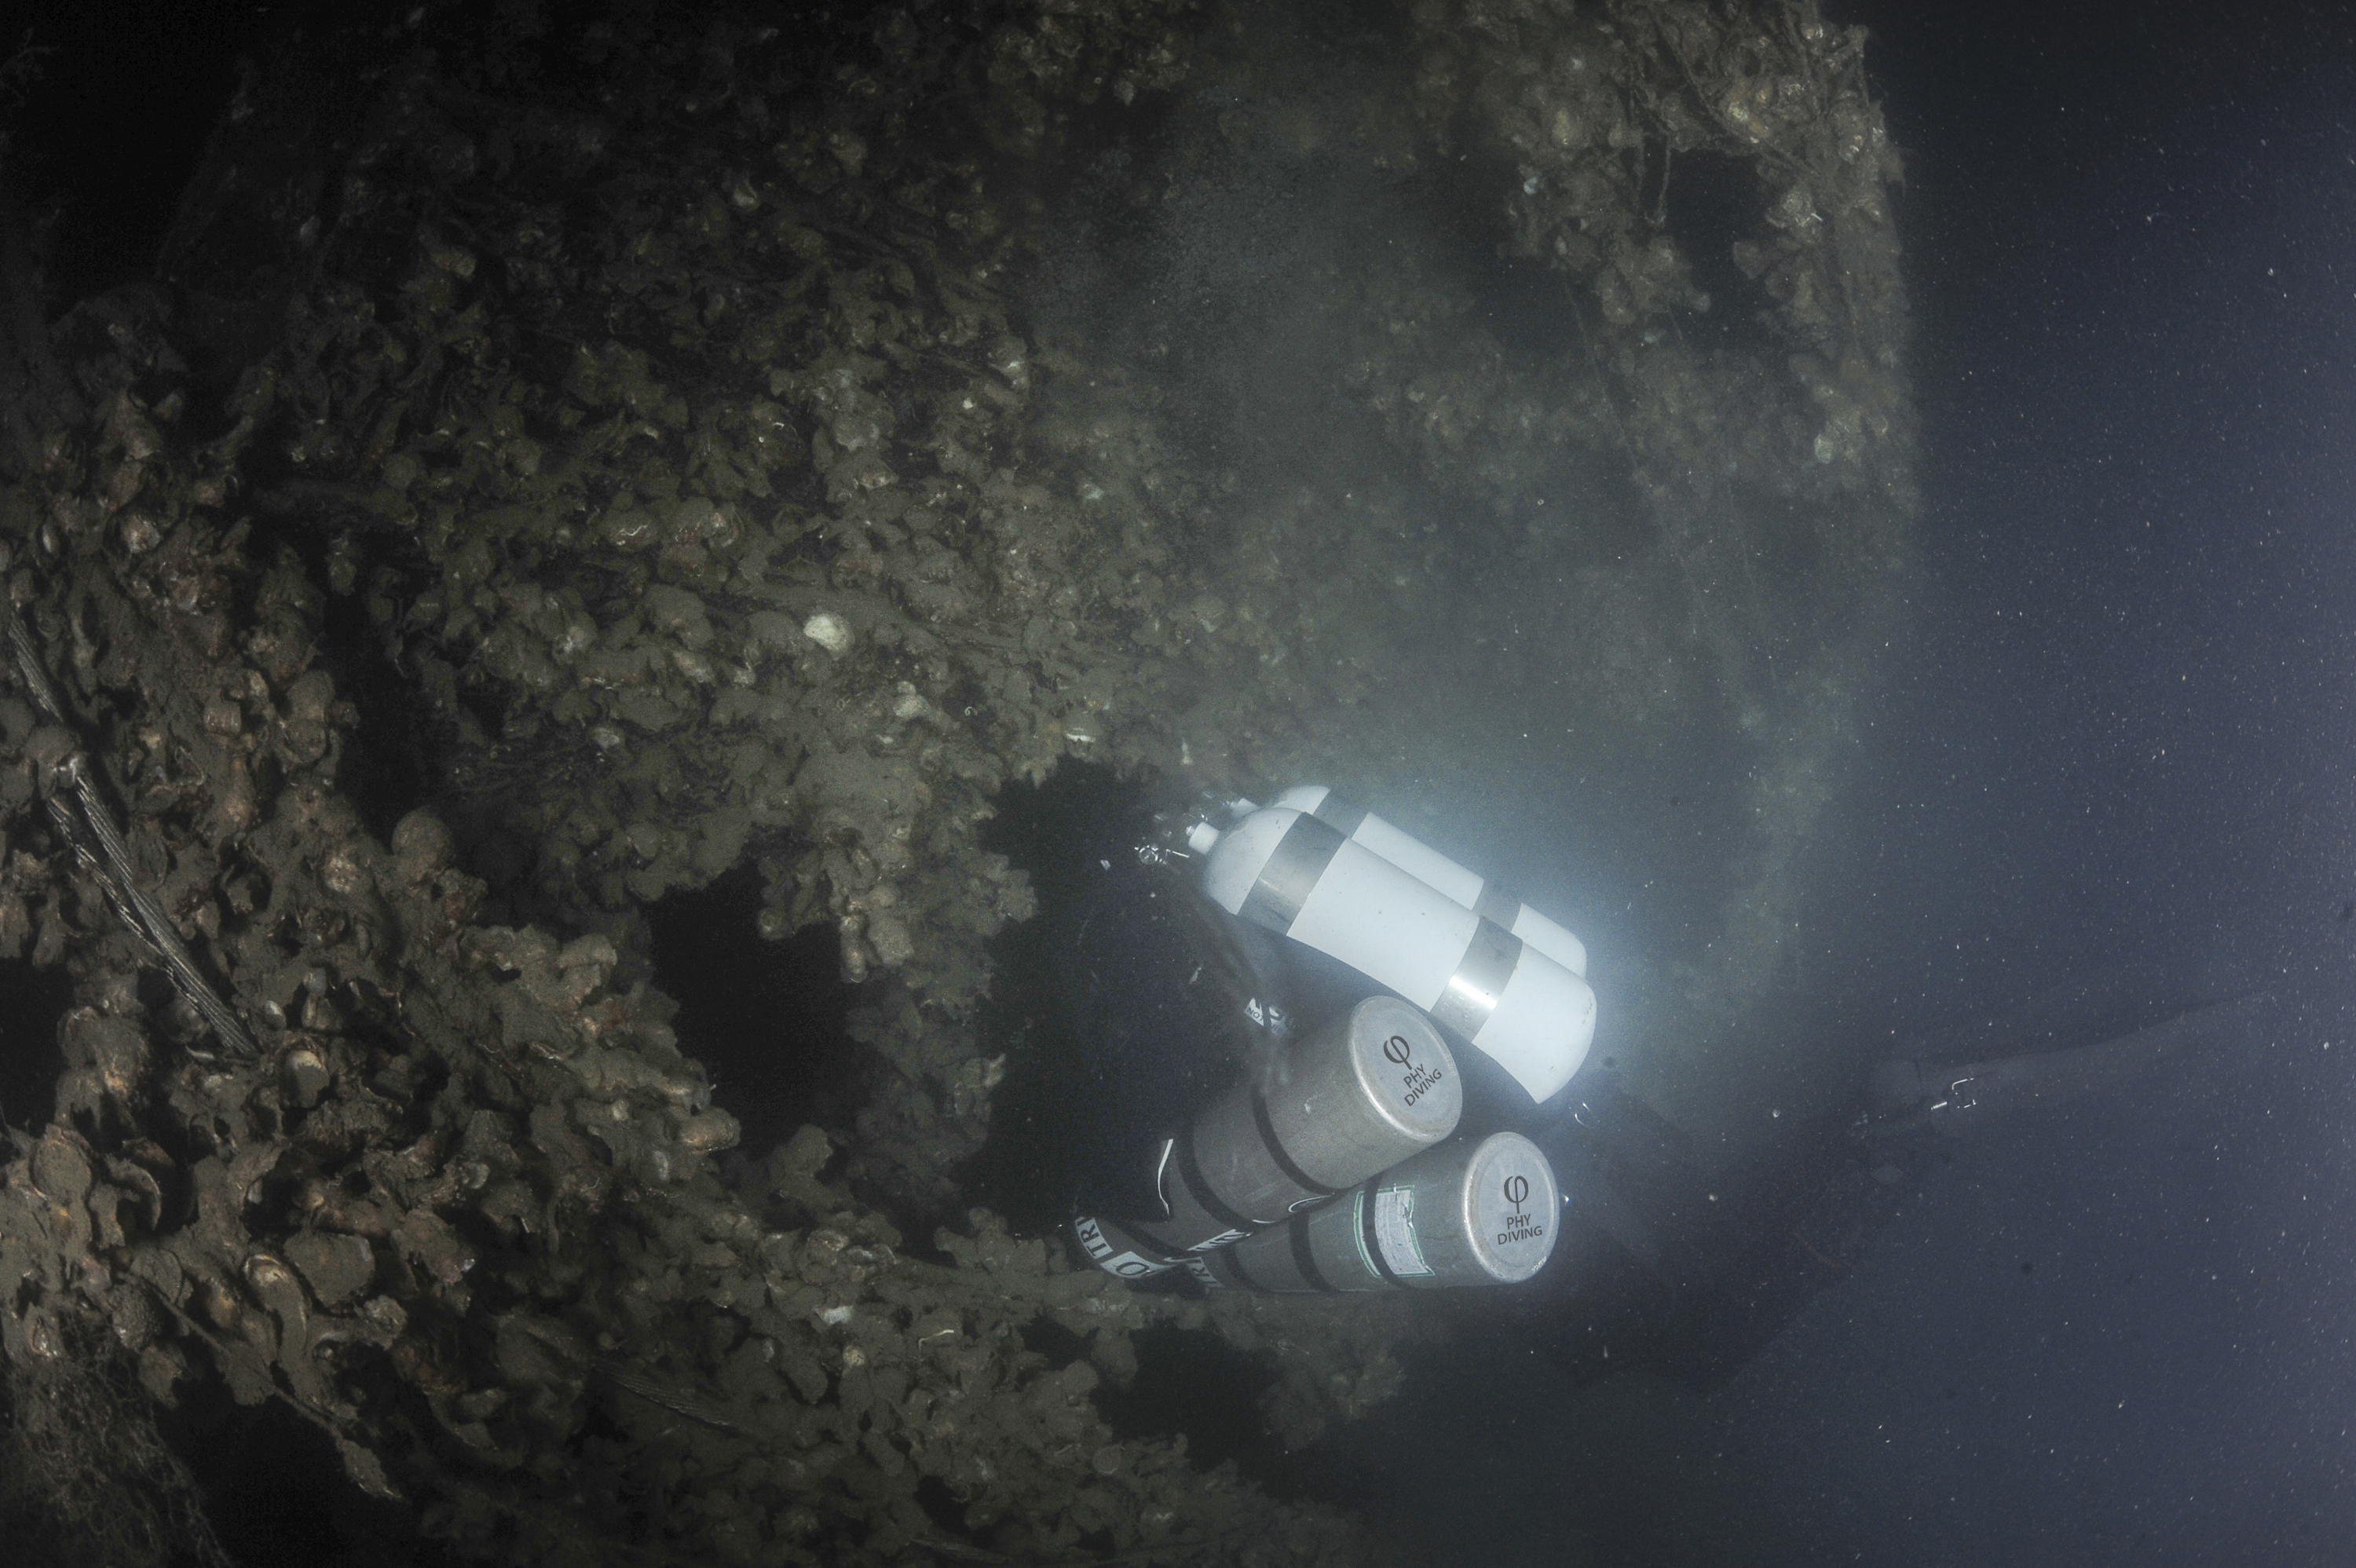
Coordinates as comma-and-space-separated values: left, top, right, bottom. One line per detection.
1322, 5, 2356, 1566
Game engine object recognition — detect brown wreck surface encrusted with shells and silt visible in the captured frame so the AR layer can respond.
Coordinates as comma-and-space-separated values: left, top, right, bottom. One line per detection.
0, 0, 1913, 1563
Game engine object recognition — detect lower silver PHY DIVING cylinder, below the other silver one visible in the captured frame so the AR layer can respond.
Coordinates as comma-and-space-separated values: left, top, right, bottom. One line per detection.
1187, 1132, 1562, 1292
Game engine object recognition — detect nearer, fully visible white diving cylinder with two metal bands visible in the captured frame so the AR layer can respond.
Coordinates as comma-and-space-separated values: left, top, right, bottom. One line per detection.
1187, 805, 1595, 1099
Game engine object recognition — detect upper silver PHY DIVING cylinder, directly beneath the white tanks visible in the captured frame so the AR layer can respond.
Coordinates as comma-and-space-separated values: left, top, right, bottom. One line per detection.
1072, 996, 1463, 1278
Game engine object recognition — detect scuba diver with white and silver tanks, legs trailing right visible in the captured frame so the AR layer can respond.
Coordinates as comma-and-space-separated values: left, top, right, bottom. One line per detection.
980, 767, 2257, 1387
